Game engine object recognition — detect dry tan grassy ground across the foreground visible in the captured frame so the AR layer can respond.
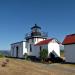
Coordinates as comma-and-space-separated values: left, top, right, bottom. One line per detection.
0, 58, 75, 75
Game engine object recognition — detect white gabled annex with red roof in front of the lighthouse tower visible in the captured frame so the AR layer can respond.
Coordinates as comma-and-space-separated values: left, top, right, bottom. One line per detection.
35, 38, 60, 57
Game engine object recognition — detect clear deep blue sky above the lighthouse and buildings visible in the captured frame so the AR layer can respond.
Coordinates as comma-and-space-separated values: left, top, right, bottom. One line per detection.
0, 0, 75, 50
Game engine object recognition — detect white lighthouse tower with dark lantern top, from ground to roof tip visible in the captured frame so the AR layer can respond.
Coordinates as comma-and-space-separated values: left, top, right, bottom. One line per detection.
25, 24, 47, 56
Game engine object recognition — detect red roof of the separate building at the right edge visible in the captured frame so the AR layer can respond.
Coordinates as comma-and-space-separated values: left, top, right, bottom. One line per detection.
62, 34, 75, 45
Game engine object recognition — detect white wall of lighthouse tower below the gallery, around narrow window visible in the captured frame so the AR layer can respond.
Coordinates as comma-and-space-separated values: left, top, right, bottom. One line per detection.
27, 38, 45, 57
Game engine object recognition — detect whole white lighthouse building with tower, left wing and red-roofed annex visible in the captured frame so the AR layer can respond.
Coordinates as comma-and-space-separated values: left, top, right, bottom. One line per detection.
11, 24, 60, 58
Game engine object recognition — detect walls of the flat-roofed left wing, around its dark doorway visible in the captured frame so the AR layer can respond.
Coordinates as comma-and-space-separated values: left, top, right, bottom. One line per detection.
11, 42, 27, 58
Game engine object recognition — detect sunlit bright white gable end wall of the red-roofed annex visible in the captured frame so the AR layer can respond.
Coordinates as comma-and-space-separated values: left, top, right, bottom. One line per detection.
48, 41, 60, 57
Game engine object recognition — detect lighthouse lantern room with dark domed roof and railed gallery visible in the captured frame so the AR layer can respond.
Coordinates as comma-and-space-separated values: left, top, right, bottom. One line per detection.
25, 24, 48, 44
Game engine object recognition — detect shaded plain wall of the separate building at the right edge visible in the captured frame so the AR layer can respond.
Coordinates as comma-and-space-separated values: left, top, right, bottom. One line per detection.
64, 44, 75, 63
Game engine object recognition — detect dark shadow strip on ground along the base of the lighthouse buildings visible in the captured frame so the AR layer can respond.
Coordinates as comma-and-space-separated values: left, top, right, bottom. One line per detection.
6, 56, 75, 65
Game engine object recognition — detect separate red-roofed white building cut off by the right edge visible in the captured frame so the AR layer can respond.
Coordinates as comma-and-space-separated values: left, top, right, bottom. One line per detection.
62, 34, 75, 63
